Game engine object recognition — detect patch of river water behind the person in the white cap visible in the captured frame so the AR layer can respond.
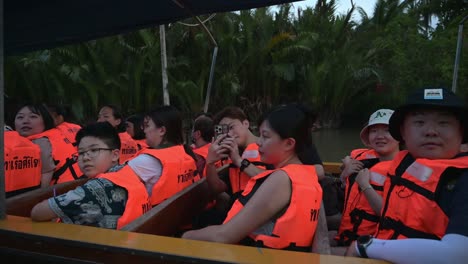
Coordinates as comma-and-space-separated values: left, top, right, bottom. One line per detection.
312, 128, 365, 162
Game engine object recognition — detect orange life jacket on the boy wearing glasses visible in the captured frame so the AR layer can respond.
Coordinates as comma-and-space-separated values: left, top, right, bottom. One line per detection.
97, 165, 151, 229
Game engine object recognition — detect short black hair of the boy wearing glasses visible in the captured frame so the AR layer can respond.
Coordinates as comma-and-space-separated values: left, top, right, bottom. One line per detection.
75, 122, 121, 149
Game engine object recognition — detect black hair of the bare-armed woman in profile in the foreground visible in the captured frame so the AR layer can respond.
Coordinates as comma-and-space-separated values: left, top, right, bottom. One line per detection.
258, 104, 315, 154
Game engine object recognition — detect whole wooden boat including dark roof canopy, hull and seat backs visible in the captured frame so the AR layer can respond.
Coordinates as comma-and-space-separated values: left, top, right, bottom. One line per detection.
0, 0, 384, 263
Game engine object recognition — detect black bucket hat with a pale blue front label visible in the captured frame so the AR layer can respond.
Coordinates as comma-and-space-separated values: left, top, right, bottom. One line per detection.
389, 88, 468, 142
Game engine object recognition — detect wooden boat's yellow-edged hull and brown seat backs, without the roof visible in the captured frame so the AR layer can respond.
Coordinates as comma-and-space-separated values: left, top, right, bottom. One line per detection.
0, 163, 384, 263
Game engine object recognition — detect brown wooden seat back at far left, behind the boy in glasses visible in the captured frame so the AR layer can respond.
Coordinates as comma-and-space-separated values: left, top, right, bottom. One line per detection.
6, 179, 89, 217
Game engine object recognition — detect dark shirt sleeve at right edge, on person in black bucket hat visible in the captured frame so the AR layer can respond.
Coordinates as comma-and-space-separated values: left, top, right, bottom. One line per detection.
437, 171, 468, 236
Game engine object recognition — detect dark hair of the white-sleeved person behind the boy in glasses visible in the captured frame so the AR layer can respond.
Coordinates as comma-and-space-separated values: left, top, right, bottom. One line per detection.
146, 105, 184, 145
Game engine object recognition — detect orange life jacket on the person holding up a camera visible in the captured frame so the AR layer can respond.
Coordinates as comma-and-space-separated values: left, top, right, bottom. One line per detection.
229, 143, 266, 194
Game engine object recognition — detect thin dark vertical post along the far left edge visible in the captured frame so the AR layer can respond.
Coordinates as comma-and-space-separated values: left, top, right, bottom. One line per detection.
0, 0, 6, 219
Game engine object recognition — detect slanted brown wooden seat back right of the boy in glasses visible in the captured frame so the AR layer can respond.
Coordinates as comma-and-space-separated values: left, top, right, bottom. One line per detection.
122, 178, 213, 236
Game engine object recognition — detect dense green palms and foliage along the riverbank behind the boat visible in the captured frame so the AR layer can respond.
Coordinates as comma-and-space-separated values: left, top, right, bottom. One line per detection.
5, 0, 468, 127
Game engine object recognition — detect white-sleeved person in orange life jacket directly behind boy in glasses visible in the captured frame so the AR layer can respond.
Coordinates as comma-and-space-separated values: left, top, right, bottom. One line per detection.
128, 106, 204, 206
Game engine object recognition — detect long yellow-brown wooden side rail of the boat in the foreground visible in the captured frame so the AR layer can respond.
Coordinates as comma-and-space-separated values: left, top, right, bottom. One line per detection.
0, 216, 387, 264
